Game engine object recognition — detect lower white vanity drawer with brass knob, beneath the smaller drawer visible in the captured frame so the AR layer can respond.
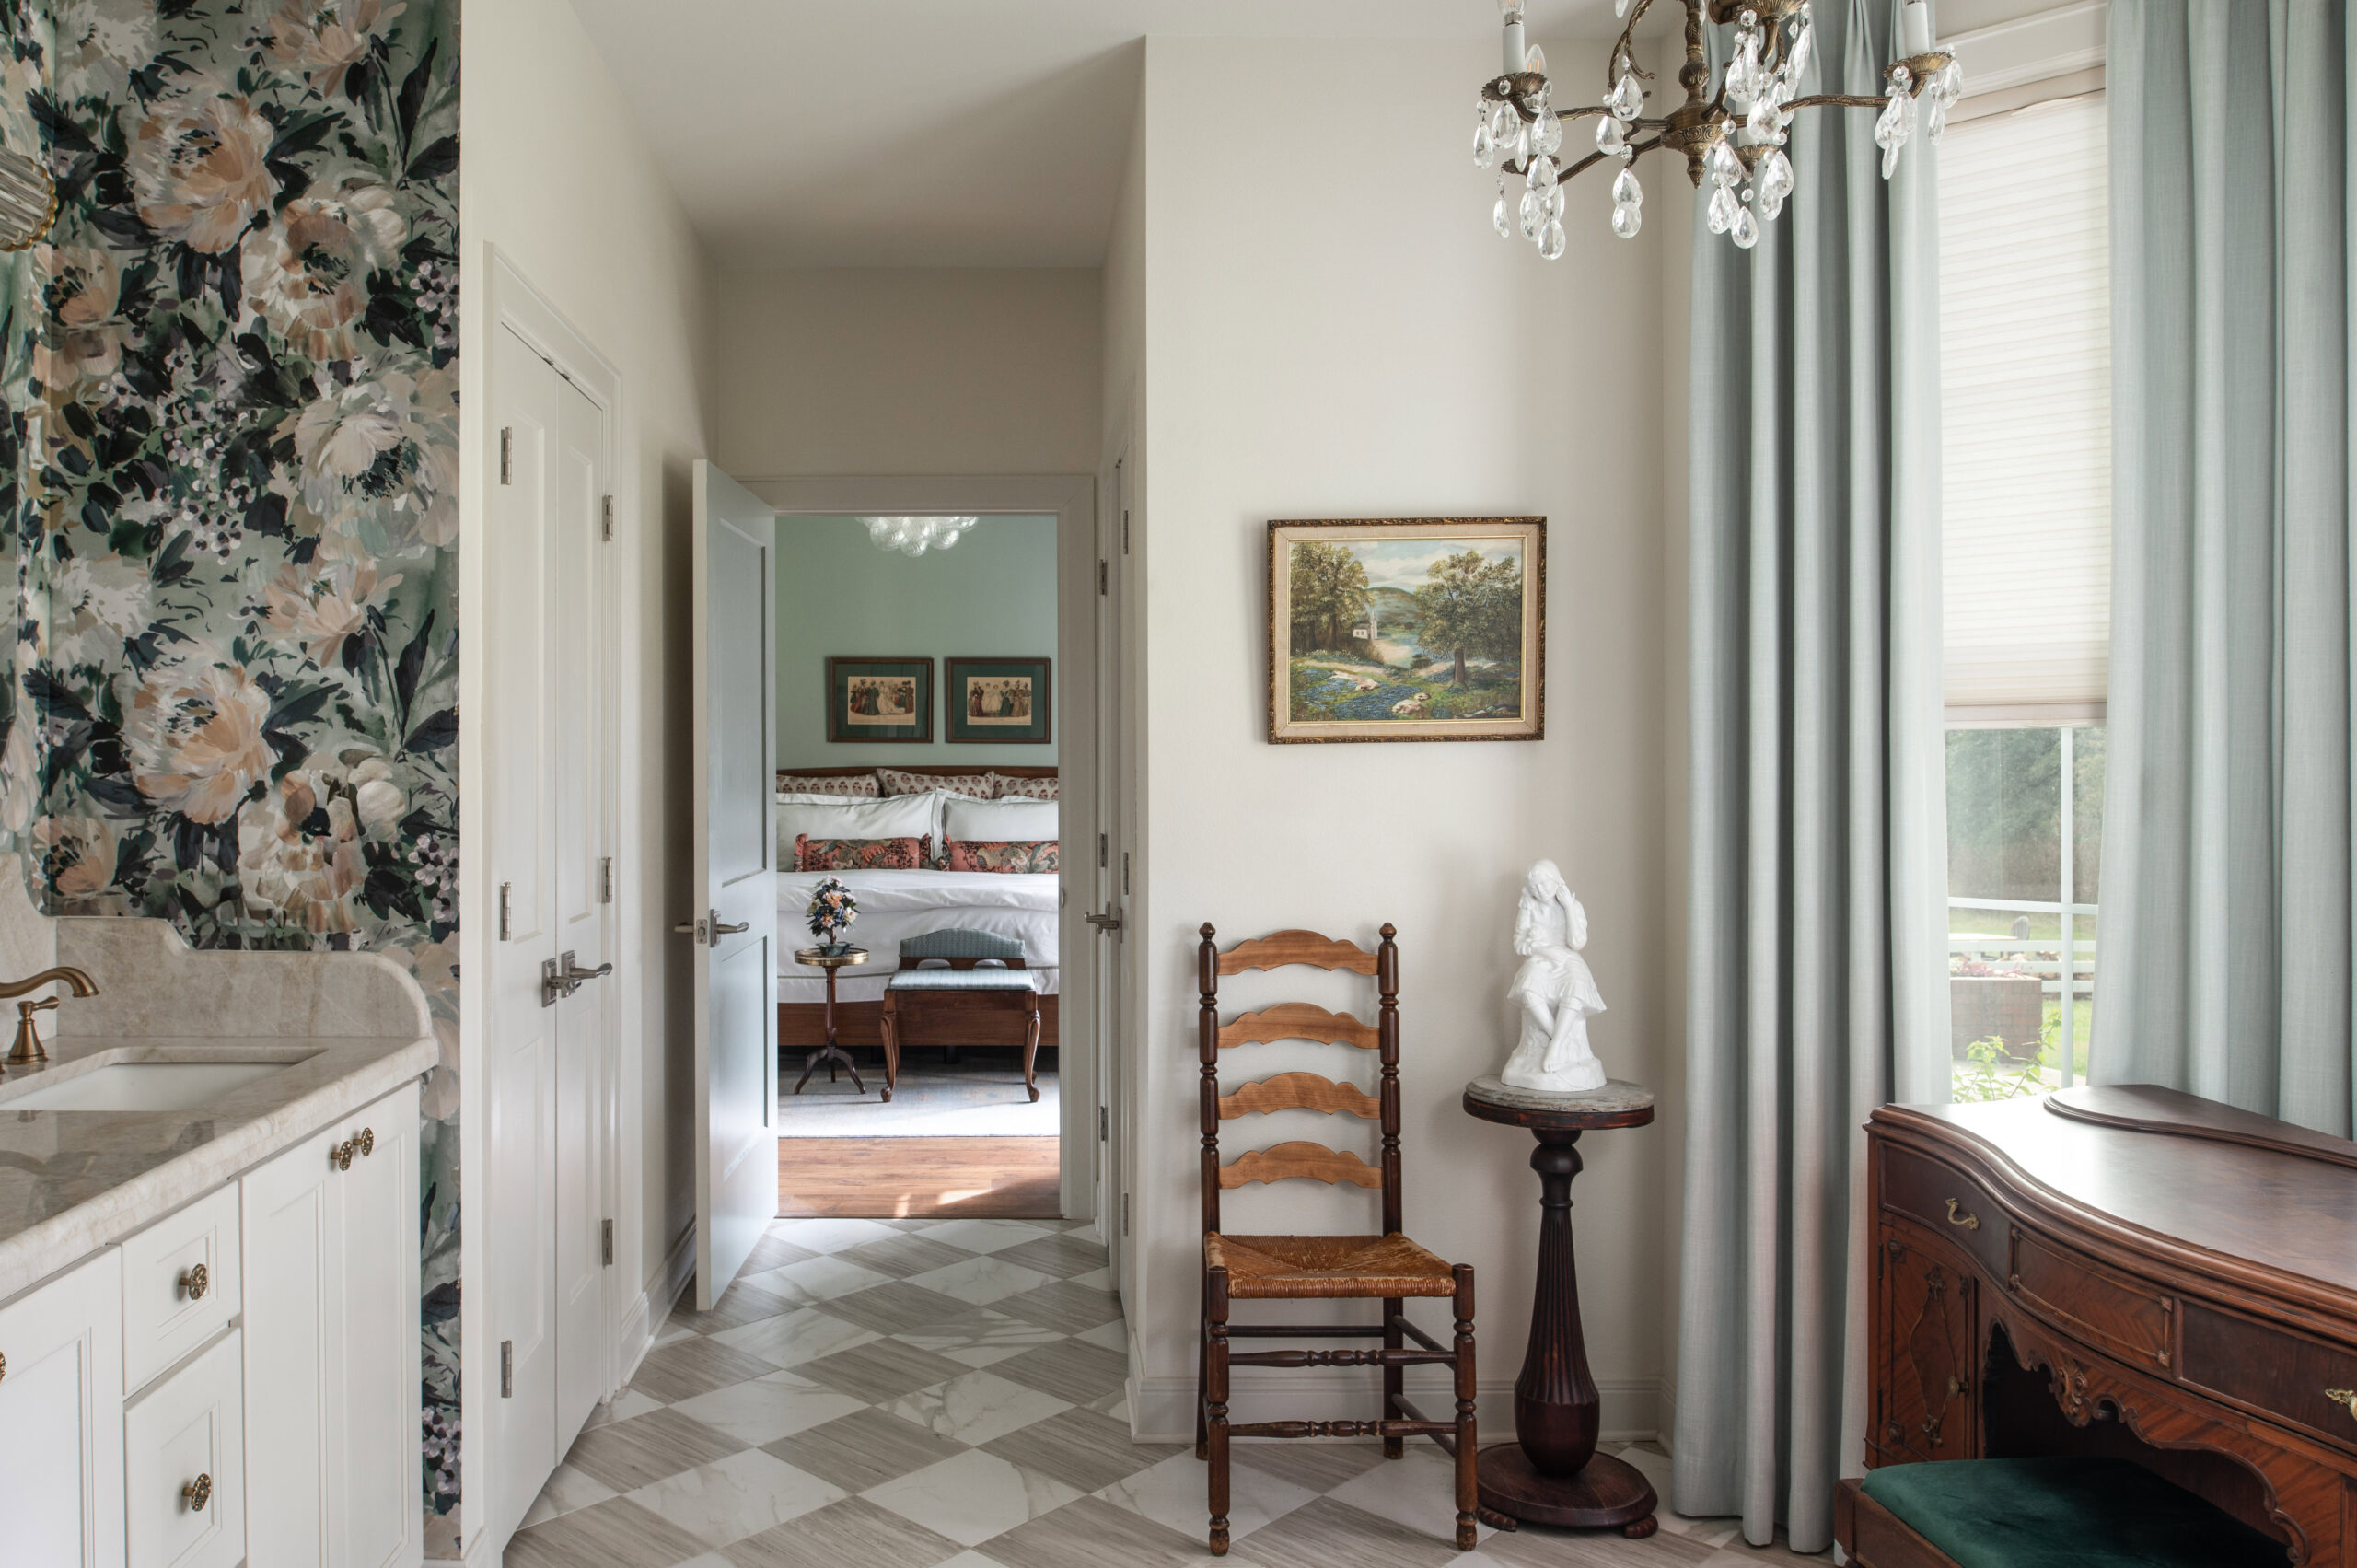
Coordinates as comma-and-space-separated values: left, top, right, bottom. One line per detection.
122, 1330, 245, 1568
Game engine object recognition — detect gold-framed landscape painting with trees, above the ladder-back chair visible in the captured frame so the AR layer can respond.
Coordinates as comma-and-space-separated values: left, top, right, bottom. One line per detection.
1268, 517, 1546, 743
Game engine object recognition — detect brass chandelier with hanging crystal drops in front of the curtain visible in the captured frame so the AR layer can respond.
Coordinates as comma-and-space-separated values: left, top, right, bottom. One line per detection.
1473, 0, 1963, 261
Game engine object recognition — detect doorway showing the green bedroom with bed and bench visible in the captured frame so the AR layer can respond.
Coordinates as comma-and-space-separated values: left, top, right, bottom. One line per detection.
748, 476, 1106, 1219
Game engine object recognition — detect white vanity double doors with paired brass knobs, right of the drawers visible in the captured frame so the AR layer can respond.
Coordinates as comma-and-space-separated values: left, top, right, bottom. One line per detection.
238, 1085, 424, 1568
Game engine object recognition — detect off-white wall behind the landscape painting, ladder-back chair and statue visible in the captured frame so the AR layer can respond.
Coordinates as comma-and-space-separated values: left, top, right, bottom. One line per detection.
1108, 38, 1688, 1438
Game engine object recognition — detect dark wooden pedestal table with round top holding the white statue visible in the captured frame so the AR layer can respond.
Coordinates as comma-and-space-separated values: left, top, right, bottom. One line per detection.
1464, 1077, 1659, 1538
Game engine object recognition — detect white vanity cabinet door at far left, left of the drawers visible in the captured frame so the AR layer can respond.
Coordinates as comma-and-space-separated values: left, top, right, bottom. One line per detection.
0, 1248, 122, 1568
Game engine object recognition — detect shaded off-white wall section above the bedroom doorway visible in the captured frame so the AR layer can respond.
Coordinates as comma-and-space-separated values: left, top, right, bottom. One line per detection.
712, 266, 1103, 479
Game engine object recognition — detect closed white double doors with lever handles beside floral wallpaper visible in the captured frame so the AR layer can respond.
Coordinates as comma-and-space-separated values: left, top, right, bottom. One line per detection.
485, 320, 615, 1538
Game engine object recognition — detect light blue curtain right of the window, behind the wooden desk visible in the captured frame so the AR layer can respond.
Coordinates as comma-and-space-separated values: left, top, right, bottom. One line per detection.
2088, 0, 2357, 1136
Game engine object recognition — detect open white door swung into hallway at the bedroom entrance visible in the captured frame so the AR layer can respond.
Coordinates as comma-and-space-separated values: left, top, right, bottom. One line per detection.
679, 459, 778, 1311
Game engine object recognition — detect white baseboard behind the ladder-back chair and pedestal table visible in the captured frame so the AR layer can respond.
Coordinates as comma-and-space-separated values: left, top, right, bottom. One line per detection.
1129, 1367, 1664, 1443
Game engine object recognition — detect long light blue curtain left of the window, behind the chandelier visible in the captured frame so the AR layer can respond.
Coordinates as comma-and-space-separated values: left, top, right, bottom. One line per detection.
1671, 0, 1949, 1551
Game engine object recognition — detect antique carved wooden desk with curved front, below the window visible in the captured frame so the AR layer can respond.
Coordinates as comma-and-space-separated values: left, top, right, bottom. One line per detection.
1867, 1087, 2357, 1568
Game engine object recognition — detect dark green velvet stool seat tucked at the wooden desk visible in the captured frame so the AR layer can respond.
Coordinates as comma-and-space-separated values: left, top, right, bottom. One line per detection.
1836, 1458, 2291, 1568
